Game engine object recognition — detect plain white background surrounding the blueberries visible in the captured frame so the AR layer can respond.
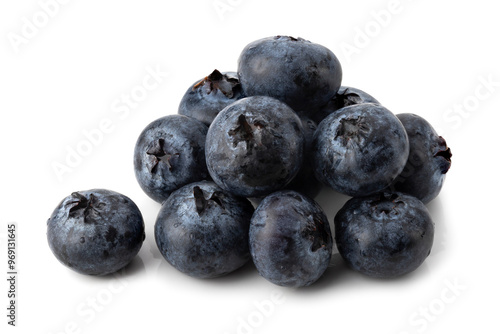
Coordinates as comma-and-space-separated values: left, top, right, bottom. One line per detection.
0, 0, 500, 334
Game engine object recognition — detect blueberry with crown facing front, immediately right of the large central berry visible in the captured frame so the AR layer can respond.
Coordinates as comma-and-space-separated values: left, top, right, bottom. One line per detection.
313, 104, 409, 196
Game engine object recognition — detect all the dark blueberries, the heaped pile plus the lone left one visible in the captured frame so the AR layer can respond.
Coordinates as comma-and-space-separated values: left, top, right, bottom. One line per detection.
47, 36, 451, 287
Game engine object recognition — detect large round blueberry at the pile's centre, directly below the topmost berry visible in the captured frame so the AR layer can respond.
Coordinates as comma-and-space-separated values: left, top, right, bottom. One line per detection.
206, 96, 304, 197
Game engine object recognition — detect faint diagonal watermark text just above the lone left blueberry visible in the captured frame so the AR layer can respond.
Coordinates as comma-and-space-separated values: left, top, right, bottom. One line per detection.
51, 65, 168, 182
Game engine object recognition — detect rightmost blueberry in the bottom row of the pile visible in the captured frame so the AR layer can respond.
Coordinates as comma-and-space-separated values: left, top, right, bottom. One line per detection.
335, 193, 434, 278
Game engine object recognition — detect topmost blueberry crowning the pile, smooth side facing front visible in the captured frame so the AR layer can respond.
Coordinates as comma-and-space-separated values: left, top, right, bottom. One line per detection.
238, 36, 342, 115
